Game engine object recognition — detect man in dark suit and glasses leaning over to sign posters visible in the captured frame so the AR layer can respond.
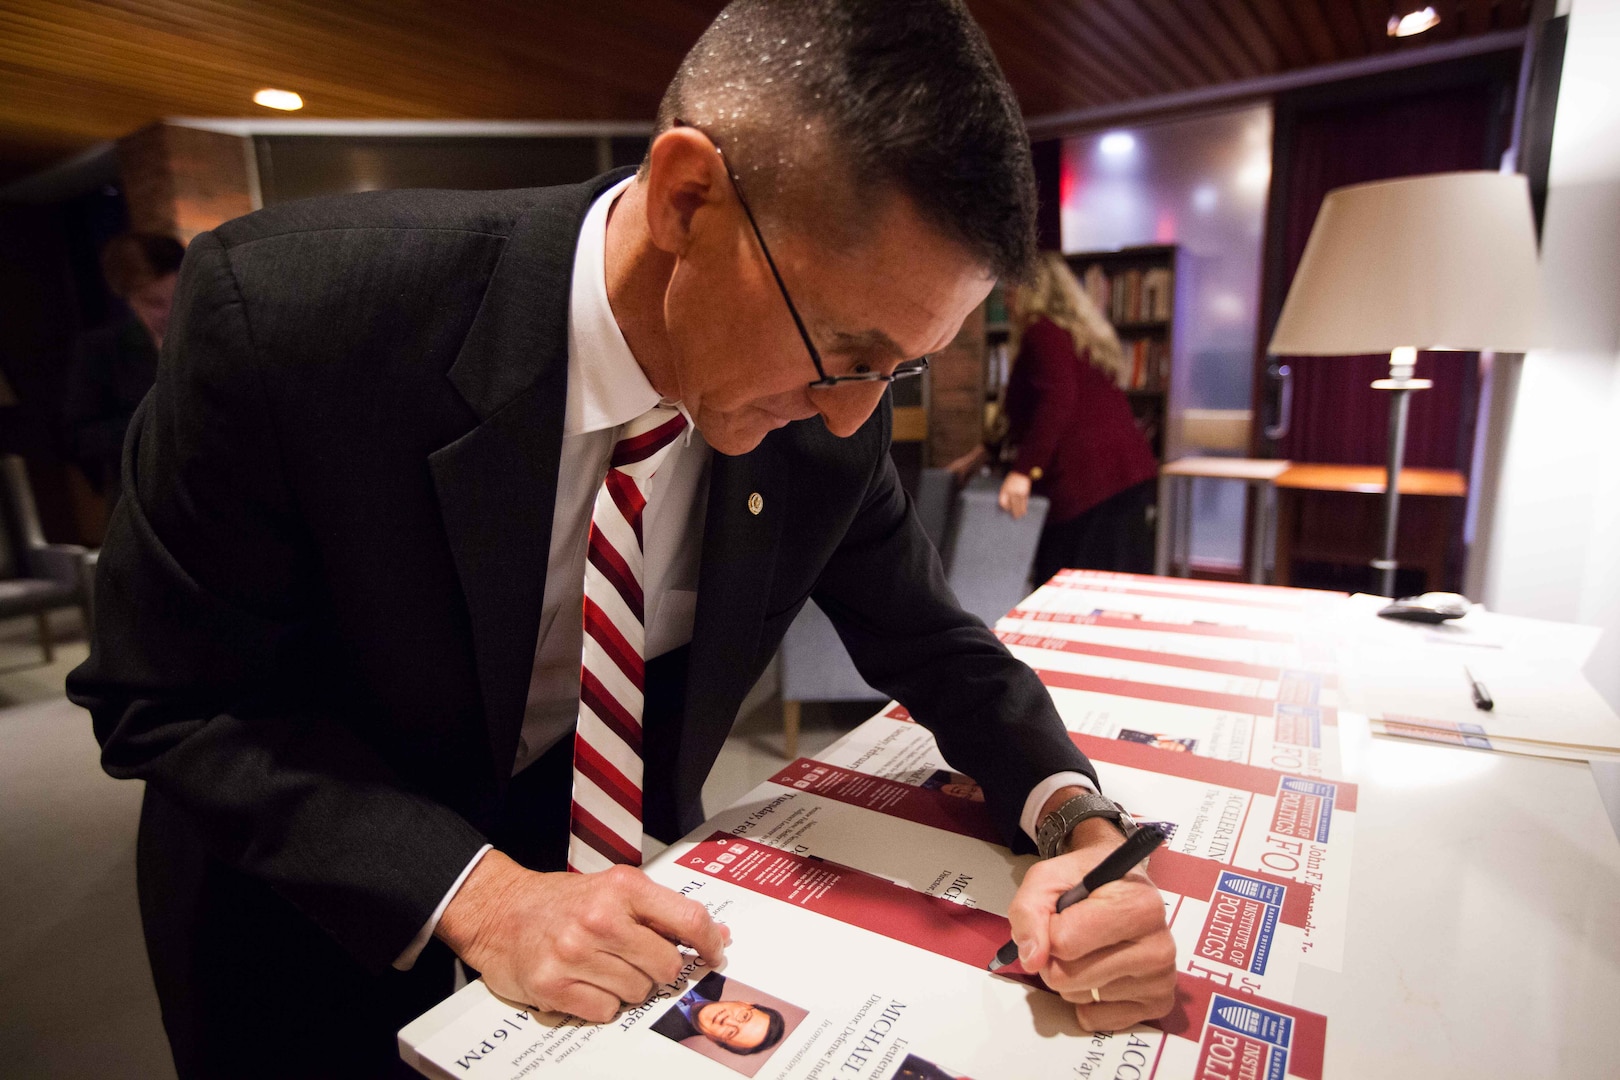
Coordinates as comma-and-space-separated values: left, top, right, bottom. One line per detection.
70, 0, 1175, 1077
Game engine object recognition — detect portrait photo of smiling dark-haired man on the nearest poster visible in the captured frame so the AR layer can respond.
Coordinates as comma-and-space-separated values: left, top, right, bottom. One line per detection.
651, 972, 810, 1077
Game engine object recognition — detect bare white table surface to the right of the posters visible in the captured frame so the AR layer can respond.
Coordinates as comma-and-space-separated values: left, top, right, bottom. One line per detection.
1294, 722, 1620, 1080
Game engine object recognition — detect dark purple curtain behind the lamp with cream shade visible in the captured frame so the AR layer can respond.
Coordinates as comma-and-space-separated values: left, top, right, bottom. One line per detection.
1277, 84, 1500, 471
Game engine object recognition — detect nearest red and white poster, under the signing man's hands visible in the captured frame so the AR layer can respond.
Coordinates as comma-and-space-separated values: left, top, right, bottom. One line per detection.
400, 837, 1327, 1080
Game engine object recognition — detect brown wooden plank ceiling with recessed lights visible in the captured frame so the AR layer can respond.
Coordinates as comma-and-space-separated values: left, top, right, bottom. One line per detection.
0, 0, 1531, 181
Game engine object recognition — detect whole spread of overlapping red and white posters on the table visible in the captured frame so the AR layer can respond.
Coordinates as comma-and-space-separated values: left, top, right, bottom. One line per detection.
400, 572, 1358, 1080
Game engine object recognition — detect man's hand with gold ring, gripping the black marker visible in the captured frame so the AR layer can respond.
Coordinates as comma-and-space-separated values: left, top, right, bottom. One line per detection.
1008, 818, 1176, 1031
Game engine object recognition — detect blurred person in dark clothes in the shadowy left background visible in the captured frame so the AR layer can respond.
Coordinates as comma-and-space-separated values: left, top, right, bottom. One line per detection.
62, 233, 186, 510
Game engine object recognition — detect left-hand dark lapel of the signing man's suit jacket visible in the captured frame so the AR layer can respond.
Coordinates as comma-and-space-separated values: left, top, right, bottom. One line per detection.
428, 172, 625, 784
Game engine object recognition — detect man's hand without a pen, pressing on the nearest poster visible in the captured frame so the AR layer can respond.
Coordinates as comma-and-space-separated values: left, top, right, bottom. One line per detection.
434, 852, 731, 1023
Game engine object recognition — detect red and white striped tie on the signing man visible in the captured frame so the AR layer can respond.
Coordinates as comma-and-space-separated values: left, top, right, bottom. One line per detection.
569, 405, 687, 874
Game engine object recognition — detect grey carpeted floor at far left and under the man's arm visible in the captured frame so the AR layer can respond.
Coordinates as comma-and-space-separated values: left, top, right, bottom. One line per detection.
0, 610, 875, 1080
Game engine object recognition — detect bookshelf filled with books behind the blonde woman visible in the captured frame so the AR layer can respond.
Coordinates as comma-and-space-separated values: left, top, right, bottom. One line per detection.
983, 244, 1176, 461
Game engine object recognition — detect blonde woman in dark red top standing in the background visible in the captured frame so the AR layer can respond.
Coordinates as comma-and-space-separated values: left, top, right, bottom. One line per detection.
1001, 251, 1158, 585
